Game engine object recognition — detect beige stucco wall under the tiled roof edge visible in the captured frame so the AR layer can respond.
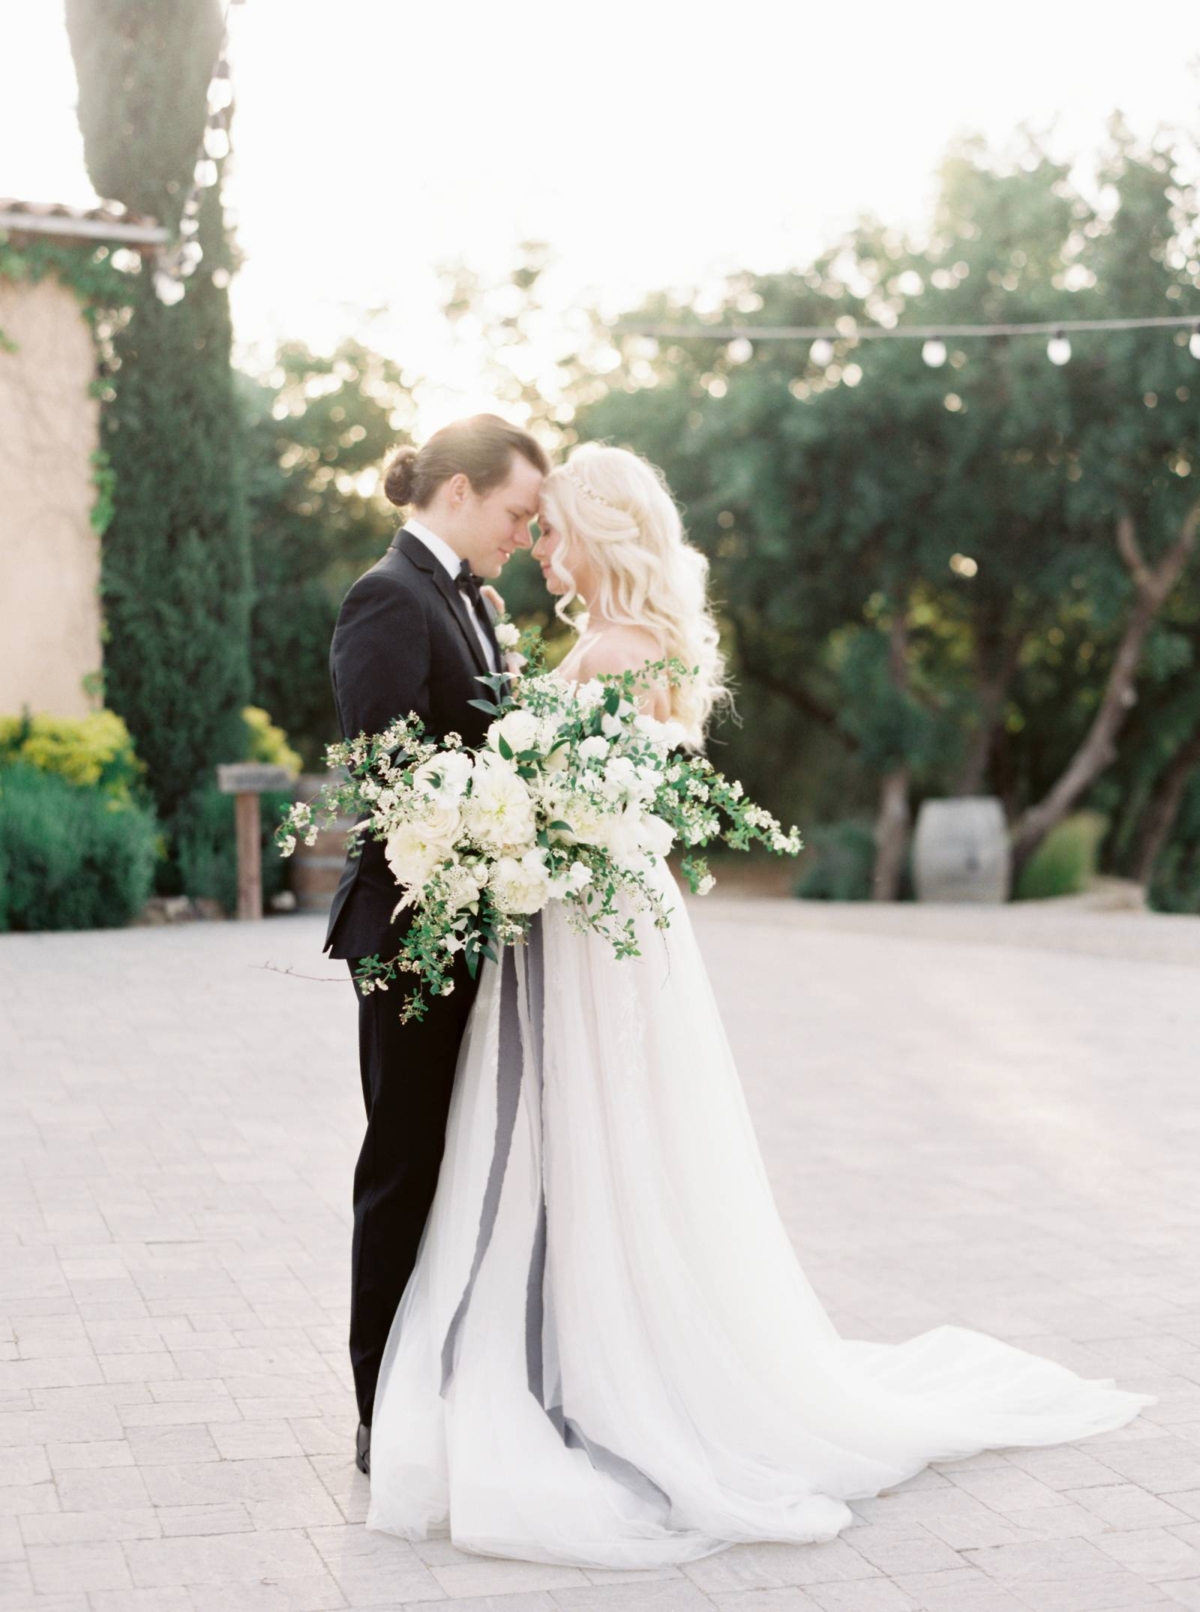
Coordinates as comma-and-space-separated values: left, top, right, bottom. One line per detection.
0, 279, 102, 716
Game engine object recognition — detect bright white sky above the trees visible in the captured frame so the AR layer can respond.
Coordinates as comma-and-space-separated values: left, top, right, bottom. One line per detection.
0, 0, 1200, 429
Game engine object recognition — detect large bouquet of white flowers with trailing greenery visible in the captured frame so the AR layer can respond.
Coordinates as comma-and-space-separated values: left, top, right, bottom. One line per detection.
276, 638, 802, 1020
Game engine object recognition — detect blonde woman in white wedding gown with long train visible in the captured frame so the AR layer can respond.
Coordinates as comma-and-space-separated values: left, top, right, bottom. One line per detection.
366, 445, 1153, 1568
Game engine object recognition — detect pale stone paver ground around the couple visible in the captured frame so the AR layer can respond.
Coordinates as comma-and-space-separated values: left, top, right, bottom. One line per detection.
0, 899, 1200, 1612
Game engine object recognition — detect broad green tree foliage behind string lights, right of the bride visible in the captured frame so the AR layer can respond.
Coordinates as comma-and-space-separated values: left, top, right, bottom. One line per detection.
566, 119, 1200, 899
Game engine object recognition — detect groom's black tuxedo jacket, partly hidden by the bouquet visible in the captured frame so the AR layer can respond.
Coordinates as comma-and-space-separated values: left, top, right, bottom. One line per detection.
324, 527, 492, 958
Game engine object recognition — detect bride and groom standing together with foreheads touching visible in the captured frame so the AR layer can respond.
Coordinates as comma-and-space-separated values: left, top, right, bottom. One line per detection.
326, 414, 1153, 1568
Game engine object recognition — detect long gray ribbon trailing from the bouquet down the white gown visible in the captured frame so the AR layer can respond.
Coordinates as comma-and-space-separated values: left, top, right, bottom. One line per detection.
442, 914, 671, 1523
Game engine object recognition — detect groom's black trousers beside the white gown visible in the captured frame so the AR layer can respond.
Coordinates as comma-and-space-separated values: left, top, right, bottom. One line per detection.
348, 956, 476, 1427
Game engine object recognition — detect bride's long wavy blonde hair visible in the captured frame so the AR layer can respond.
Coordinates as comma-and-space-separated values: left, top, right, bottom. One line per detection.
542, 442, 726, 746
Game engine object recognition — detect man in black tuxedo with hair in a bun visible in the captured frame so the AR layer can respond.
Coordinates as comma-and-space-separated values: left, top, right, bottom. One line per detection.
326, 414, 548, 1472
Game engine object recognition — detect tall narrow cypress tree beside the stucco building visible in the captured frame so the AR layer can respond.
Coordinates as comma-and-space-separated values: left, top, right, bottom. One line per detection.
66, 0, 250, 885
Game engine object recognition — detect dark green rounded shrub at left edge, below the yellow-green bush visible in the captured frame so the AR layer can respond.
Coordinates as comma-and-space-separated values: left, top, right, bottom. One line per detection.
0, 762, 156, 930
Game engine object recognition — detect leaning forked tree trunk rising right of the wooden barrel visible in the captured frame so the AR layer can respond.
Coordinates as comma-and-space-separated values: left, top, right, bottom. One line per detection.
1013, 503, 1200, 872
